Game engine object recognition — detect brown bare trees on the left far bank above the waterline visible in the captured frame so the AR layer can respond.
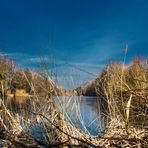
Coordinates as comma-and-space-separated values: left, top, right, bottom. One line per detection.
0, 56, 62, 96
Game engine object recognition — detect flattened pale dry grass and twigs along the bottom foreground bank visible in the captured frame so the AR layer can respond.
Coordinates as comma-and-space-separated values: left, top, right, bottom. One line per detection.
0, 106, 148, 147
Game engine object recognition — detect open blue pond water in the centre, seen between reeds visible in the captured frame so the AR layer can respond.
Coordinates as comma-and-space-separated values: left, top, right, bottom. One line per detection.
56, 96, 107, 136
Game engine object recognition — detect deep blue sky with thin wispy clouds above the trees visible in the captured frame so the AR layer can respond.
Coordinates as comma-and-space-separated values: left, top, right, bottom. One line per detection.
0, 0, 148, 88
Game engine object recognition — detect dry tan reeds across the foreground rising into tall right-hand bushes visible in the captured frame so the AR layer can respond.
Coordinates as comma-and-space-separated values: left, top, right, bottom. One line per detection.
0, 56, 148, 148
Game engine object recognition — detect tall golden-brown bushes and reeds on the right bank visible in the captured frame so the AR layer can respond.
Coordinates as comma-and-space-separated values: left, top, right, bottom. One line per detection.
96, 59, 148, 126
